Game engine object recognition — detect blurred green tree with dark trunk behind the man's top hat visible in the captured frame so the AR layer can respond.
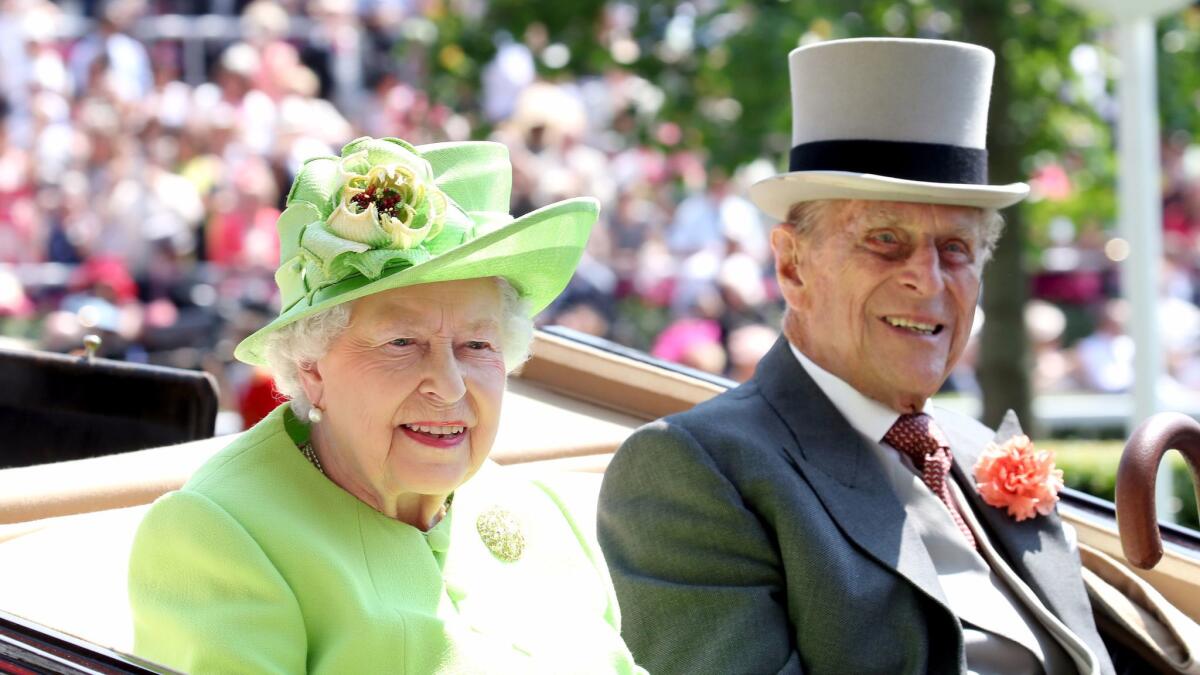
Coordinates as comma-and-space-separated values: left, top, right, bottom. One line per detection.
427, 0, 1147, 423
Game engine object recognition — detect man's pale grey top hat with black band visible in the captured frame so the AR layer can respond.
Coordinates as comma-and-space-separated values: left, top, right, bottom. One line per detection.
750, 38, 1030, 220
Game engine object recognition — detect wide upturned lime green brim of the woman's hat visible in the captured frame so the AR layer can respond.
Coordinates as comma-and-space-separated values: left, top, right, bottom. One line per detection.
234, 197, 600, 365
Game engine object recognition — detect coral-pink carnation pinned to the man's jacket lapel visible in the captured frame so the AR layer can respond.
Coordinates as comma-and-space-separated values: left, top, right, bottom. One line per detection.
974, 435, 1062, 522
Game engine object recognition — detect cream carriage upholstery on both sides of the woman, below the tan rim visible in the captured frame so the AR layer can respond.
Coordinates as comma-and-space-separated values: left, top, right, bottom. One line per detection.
0, 380, 643, 652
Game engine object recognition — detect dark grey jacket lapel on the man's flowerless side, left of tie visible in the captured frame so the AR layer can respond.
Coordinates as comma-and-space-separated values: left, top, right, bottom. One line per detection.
755, 338, 949, 611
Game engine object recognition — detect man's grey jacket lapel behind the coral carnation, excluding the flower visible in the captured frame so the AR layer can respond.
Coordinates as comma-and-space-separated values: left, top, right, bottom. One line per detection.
937, 411, 1091, 627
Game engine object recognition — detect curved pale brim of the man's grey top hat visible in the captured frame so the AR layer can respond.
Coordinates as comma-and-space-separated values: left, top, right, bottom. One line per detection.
750, 171, 1030, 222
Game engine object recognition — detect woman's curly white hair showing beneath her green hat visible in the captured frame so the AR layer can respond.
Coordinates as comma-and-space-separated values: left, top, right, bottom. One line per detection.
270, 277, 533, 422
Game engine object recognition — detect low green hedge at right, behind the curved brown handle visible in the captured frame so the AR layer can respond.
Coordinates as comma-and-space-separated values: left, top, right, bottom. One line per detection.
1060, 440, 1200, 530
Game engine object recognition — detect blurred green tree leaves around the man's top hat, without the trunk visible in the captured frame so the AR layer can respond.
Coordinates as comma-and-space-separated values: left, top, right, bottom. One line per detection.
428, 0, 1161, 253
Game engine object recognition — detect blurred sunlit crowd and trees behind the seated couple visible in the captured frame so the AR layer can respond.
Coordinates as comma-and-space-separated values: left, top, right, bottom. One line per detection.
0, 0, 1200, 524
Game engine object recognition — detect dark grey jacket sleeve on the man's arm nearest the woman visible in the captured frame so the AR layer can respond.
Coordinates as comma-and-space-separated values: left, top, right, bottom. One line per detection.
598, 422, 800, 674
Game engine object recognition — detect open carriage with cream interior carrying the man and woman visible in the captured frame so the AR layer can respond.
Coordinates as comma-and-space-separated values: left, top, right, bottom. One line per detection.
0, 333, 1200, 674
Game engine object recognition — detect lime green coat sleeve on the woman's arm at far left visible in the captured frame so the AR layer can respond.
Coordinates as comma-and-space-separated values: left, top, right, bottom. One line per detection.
130, 491, 307, 673
